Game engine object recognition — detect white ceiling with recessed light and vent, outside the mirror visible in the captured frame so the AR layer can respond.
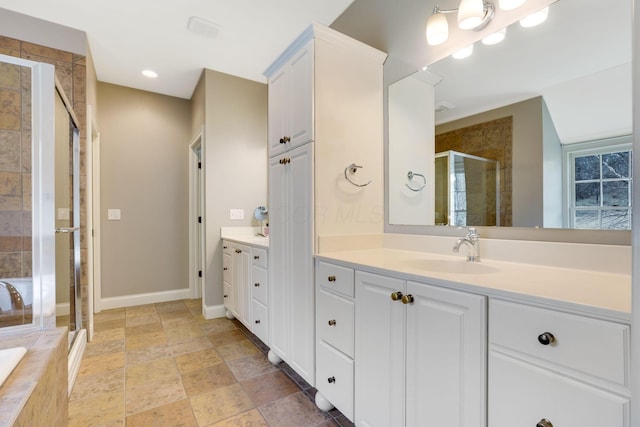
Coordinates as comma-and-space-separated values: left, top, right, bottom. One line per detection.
0, 0, 353, 99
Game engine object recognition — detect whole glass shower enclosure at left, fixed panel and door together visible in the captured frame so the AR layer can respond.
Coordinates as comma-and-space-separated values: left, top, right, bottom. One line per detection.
0, 55, 82, 350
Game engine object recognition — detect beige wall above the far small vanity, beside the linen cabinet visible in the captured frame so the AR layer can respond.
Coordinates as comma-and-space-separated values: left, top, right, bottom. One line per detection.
202, 70, 267, 306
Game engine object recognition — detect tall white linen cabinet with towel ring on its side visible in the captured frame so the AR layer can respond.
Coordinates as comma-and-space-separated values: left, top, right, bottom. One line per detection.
265, 24, 386, 392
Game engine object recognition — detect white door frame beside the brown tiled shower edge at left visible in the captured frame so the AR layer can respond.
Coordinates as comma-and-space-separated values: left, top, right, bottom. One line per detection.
87, 105, 102, 320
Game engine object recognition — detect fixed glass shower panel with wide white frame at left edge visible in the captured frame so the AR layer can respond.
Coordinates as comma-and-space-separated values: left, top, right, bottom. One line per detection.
0, 55, 55, 334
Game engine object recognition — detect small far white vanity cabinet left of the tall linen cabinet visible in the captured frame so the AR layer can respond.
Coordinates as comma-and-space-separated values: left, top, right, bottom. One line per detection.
222, 240, 269, 344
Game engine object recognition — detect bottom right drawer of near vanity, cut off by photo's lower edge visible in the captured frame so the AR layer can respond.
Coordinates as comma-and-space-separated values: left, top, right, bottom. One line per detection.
488, 352, 629, 427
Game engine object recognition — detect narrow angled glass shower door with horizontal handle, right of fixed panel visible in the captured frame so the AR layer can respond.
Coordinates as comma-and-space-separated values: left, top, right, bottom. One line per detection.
55, 86, 82, 348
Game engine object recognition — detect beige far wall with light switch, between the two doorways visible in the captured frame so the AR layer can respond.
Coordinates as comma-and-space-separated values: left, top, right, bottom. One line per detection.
97, 83, 191, 298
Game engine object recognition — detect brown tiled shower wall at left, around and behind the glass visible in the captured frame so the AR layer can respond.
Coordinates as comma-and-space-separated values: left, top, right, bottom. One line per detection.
0, 36, 88, 328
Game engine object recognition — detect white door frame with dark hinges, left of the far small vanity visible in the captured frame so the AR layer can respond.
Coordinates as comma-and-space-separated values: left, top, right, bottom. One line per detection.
189, 128, 206, 307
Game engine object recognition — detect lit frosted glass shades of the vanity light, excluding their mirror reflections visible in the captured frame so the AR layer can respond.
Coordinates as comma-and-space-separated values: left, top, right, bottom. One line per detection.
426, 0, 526, 46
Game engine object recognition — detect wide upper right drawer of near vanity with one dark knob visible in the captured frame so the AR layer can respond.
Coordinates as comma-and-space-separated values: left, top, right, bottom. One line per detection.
489, 300, 629, 386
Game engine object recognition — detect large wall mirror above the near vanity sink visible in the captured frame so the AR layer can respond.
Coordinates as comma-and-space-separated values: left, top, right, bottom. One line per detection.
386, 0, 632, 244
